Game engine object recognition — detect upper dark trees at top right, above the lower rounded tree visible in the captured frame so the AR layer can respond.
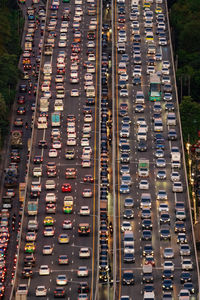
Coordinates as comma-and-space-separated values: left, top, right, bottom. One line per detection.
169, 0, 200, 102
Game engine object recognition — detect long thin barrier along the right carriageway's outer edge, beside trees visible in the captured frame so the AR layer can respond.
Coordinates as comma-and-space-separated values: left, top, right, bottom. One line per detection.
165, 0, 200, 300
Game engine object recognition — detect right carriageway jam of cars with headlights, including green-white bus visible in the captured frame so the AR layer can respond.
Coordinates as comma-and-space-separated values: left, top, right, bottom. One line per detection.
116, 0, 198, 300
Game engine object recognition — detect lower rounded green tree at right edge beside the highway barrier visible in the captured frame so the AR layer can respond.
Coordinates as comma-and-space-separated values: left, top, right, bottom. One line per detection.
180, 97, 200, 144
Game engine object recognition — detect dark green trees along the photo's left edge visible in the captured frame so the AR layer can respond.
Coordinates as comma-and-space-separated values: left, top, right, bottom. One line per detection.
0, 0, 23, 148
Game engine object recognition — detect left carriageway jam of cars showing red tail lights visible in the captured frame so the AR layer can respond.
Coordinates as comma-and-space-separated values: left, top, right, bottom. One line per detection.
2, 0, 97, 299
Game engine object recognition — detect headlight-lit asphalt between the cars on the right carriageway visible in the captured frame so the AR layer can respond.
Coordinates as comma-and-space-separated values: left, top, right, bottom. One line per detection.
115, 1, 198, 299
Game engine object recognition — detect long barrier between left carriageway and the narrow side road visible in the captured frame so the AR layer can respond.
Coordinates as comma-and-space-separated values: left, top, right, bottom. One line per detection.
9, 0, 50, 300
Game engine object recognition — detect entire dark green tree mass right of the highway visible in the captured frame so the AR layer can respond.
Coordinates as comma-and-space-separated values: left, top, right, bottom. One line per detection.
168, 0, 200, 143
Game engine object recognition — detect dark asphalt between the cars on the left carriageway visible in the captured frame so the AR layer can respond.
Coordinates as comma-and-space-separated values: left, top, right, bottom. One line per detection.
15, 2, 101, 299
